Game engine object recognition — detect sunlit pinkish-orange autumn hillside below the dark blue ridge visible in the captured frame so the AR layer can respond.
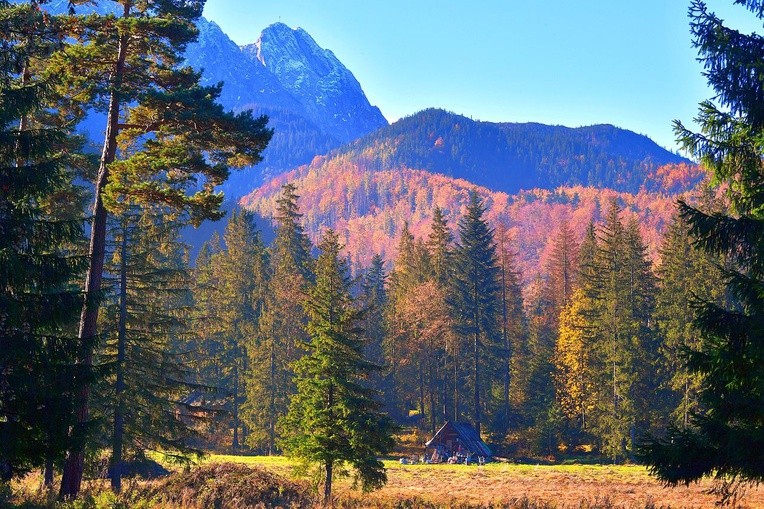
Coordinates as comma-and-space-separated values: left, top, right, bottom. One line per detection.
241, 154, 703, 282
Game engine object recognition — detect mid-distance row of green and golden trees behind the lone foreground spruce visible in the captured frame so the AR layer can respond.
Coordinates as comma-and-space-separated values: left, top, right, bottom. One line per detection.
195, 184, 724, 460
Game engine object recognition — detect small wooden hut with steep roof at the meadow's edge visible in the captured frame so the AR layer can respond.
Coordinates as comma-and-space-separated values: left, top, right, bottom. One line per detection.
424, 421, 492, 463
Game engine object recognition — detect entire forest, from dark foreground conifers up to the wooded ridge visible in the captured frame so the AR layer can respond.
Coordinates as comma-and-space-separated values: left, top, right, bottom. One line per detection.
0, 0, 764, 507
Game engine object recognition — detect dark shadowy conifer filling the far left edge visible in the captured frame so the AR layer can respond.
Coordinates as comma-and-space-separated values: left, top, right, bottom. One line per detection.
0, 1, 86, 484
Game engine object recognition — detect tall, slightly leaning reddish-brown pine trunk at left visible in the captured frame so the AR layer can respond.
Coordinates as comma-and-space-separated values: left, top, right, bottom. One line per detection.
60, 16, 131, 498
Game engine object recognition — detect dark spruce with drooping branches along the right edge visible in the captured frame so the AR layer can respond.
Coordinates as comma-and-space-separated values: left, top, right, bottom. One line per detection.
644, 0, 764, 495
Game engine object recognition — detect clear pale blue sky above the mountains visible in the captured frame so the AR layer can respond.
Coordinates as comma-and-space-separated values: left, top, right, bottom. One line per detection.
204, 0, 761, 150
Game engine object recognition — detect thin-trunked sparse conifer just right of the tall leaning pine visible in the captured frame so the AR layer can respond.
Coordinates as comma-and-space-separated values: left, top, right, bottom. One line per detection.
99, 209, 198, 493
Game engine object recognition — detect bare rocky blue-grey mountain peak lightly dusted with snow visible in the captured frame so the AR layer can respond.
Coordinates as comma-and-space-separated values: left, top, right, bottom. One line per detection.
242, 23, 387, 142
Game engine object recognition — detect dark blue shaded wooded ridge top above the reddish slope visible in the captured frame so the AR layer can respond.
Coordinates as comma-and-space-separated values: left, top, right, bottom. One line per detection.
314, 109, 696, 193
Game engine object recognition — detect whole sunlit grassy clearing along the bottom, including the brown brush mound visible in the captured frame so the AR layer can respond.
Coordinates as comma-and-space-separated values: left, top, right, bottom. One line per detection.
7, 455, 764, 509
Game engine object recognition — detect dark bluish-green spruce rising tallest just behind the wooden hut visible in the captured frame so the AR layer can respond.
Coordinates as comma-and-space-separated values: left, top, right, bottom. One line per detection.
449, 191, 501, 434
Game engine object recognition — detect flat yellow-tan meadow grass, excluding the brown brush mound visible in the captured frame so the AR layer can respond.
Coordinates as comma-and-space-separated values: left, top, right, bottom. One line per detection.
210, 456, 764, 509
